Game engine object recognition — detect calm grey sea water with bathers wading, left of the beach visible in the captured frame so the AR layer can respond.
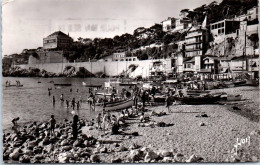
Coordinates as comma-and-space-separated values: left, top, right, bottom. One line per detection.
2, 77, 108, 131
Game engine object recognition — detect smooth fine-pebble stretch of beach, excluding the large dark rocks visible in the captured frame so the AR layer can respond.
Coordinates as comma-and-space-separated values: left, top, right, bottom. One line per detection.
89, 87, 260, 162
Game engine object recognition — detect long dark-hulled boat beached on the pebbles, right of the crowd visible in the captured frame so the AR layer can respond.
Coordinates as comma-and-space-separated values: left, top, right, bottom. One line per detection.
175, 95, 221, 105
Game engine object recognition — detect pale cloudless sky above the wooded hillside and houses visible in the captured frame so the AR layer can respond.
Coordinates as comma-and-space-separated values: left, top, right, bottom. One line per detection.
2, 0, 222, 55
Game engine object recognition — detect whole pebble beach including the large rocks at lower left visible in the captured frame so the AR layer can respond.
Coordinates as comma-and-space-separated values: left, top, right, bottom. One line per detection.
3, 87, 260, 163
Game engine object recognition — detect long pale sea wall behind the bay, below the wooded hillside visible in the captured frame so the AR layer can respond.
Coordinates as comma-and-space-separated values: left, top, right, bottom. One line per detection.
17, 59, 171, 77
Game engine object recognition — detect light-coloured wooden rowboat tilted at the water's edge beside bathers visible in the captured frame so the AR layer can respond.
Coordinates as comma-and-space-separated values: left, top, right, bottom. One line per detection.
104, 98, 134, 111
